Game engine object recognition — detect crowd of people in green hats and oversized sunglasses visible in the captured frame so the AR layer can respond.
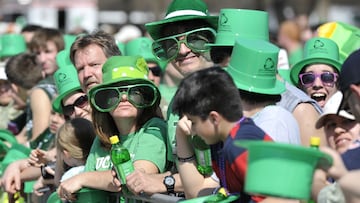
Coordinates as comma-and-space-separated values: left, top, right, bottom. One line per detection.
0, 0, 360, 203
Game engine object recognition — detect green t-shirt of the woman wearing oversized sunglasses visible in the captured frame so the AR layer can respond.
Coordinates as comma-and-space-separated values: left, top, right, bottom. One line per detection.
85, 118, 167, 173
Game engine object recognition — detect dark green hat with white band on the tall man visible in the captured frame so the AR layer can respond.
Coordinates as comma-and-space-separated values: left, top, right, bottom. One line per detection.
145, 0, 218, 40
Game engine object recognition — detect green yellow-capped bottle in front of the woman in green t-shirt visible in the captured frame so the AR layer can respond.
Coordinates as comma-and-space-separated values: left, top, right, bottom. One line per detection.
110, 135, 134, 185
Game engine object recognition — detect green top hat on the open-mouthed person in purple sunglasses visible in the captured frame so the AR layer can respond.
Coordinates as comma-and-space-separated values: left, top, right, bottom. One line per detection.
290, 37, 341, 84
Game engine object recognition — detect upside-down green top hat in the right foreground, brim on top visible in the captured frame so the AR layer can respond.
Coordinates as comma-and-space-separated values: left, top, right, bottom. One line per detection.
235, 141, 332, 199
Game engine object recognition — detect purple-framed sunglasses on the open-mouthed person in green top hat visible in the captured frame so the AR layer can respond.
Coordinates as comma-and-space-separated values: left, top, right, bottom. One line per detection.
299, 72, 338, 87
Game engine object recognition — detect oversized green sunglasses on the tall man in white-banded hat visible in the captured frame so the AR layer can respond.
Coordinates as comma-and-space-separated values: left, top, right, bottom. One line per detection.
152, 28, 216, 61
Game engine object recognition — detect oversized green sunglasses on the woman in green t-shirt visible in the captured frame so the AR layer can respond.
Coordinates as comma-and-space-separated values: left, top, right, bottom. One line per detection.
91, 84, 158, 112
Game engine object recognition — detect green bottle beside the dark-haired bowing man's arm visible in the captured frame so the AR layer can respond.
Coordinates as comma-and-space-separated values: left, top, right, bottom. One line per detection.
192, 135, 213, 176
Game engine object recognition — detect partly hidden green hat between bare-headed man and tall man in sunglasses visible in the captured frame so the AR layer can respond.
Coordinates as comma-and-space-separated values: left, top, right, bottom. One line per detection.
125, 37, 166, 70
